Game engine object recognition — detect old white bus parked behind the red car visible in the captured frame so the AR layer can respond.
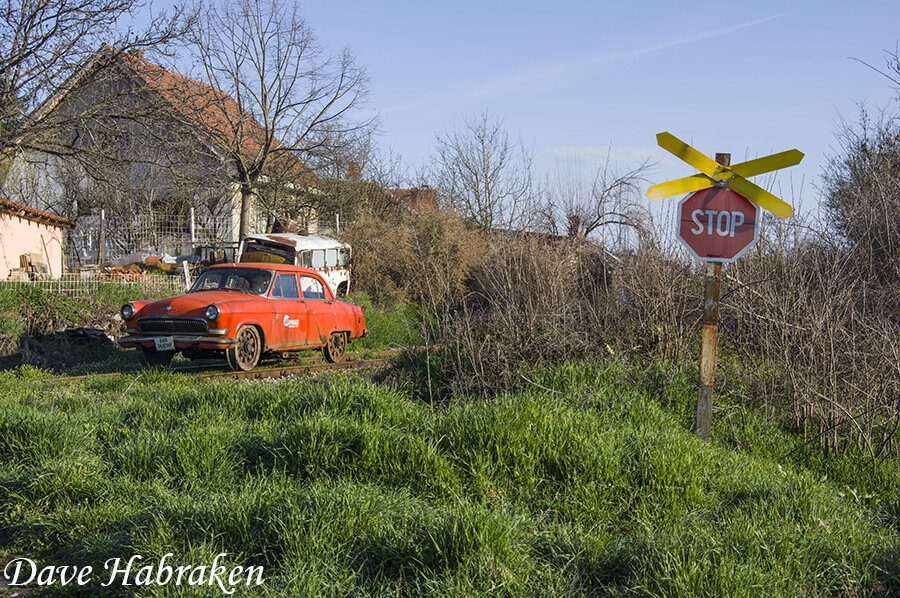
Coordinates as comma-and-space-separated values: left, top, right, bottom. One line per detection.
238, 233, 350, 297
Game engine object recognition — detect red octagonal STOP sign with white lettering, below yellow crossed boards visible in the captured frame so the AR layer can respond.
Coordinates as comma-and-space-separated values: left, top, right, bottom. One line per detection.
678, 187, 759, 262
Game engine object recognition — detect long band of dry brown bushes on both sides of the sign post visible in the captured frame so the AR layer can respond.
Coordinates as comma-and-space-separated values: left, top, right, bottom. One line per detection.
346, 199, 900, 462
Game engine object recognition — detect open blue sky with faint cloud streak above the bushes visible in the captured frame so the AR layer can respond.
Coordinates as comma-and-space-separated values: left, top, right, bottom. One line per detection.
302, 0, 900, 216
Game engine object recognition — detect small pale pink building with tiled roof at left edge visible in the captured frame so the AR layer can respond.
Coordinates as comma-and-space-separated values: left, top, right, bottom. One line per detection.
0, 198, 77, 280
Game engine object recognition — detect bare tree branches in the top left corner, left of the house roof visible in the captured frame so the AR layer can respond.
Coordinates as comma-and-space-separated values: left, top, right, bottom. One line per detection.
0, 0, 192, 158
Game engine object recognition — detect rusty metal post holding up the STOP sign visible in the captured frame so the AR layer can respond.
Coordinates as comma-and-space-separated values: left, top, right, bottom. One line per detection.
694, 154, 731, 442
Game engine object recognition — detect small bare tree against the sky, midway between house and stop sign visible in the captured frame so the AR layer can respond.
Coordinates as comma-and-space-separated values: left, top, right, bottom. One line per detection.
435, 112, 534, 229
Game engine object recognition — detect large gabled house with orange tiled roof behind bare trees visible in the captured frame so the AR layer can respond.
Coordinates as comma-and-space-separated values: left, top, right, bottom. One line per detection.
3, 45, 316, 259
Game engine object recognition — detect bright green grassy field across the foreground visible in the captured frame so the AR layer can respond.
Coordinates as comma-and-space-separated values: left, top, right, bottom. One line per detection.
0, 363, 900, 597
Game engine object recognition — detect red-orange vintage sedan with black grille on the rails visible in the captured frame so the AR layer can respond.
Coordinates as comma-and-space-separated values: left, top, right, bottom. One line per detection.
119, 264, 367, 370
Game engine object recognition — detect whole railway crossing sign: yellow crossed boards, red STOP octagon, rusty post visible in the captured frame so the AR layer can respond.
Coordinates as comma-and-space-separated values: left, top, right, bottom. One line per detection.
647, 133, 803, 442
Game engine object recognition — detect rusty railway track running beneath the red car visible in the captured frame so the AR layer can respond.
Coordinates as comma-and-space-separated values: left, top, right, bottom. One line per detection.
47, 348, 409, 382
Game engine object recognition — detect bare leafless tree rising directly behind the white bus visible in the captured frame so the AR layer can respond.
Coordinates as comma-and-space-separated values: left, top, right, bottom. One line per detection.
191, 0, 371, 237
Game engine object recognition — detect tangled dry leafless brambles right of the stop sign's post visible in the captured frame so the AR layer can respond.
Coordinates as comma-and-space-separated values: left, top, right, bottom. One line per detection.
721, 224, 900, 463
